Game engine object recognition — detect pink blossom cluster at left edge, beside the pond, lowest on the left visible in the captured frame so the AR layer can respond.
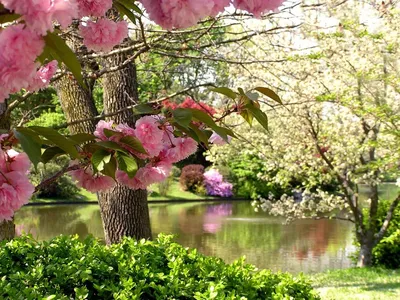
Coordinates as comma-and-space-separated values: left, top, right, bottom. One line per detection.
0, 143, 35, 222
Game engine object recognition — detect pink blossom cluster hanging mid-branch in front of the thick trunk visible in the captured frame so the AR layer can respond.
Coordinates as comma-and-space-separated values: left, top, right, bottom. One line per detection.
71, 116, 197, 192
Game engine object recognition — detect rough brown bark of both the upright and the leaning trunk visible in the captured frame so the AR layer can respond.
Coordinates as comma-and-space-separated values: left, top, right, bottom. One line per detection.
56, 48, 151, 244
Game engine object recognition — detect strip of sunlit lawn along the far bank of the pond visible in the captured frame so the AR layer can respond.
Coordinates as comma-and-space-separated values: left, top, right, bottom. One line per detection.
32, 180, 216, 203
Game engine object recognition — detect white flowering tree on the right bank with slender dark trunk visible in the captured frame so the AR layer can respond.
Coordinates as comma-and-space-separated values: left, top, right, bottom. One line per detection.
209, 1, 400, 266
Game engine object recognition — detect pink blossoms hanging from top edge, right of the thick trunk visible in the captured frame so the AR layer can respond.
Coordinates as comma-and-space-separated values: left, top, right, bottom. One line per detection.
141, 0, 285, 29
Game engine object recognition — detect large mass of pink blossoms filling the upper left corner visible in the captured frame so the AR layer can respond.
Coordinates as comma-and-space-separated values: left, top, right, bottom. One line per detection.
0, 0, 128, 103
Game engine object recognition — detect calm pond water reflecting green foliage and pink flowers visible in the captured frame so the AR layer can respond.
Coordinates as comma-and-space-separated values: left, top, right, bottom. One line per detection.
15, 201, 353, 272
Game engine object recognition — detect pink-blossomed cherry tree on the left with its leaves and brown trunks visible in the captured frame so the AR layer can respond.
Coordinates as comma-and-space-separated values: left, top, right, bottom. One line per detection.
0, 0, 290, 243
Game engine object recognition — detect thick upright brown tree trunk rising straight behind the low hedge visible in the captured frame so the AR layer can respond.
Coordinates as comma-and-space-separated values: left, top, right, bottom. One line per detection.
99, 55, 151, 244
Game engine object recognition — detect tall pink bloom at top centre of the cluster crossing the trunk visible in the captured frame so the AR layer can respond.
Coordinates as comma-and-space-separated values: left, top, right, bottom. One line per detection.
135, 116, 164, 157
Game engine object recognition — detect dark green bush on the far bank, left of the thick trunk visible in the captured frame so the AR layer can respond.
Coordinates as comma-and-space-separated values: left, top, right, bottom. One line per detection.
29, 157, 79, 200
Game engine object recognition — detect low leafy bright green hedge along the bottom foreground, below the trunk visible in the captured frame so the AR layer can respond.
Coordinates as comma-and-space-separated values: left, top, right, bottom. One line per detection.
0, 235, 319, 300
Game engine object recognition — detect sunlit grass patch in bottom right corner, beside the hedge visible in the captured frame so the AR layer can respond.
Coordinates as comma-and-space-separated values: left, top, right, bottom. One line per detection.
310, 268, 400, 300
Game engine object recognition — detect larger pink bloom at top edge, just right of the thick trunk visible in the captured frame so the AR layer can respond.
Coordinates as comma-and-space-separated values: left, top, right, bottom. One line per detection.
142, 0, 216, 29
